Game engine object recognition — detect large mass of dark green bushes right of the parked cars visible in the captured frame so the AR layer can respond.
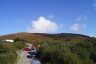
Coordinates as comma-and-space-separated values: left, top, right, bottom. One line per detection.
37, 38, 96, 64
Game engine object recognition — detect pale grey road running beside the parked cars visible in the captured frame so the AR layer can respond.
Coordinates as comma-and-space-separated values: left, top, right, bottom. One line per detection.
17, 43, 32, 64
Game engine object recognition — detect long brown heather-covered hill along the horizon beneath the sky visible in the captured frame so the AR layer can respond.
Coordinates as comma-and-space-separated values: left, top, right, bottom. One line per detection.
0, 32, 89, 44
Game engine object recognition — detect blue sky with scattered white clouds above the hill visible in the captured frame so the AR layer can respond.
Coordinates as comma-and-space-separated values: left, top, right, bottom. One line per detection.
0, 0, 96, 36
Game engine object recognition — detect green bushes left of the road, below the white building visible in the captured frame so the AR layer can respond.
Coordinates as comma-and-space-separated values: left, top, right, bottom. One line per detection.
0, 37, 26, 64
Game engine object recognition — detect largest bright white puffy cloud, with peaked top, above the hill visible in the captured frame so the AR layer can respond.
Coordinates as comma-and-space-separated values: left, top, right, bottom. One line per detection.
27, 17, 60, 33
